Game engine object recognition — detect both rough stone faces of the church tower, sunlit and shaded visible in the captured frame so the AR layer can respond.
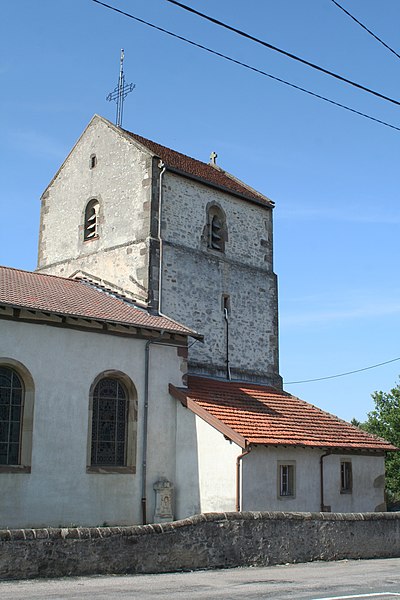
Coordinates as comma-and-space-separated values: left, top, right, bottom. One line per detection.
38, 116, 281, 387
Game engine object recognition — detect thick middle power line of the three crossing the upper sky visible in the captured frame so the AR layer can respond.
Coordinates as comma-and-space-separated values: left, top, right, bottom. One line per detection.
166, 0, 400, 106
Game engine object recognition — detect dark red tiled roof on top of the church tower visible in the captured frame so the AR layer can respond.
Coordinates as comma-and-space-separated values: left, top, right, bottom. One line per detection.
124, 130, 274, 207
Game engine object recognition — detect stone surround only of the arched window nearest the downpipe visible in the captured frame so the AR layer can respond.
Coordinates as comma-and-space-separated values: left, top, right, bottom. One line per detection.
86, 370, 138, 474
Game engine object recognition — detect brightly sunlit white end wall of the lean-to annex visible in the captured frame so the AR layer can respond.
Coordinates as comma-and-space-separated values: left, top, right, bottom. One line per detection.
196, 416, 242, 512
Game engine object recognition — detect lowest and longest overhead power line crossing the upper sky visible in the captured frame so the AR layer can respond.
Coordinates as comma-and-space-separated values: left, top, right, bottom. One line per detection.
92, 0, 400, 131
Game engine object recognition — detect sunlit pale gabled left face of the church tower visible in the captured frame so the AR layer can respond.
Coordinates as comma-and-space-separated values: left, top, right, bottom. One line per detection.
38, 117, 151, 299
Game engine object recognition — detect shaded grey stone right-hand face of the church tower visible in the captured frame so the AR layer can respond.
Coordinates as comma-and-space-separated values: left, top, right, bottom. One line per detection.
161, 171, 280, 386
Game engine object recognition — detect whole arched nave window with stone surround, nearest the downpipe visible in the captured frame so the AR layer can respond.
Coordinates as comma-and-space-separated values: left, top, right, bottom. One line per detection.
88, 372, 137, 472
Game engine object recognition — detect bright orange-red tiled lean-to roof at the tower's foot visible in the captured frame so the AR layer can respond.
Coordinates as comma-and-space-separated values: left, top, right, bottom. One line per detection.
170, 376, 396, 451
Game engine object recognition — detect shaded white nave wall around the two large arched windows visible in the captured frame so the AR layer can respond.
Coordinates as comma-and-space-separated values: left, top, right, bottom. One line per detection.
0, 320, 182, 527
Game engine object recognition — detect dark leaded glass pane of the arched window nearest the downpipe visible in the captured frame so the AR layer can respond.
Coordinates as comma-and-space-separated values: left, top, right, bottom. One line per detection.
91, 378, 128, 467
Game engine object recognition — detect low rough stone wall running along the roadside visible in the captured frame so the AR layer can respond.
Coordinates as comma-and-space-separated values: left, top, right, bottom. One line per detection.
0, 512, 400, 579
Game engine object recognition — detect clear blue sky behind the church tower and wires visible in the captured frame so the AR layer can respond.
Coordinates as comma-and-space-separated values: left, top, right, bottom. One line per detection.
0, 0, 400, 420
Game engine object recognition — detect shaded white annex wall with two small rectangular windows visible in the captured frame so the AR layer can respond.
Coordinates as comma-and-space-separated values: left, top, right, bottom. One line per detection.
242, 447, 384, 512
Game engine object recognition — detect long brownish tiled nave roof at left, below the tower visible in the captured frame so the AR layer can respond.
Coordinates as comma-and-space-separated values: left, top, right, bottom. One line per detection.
0, 266, 200, 337
